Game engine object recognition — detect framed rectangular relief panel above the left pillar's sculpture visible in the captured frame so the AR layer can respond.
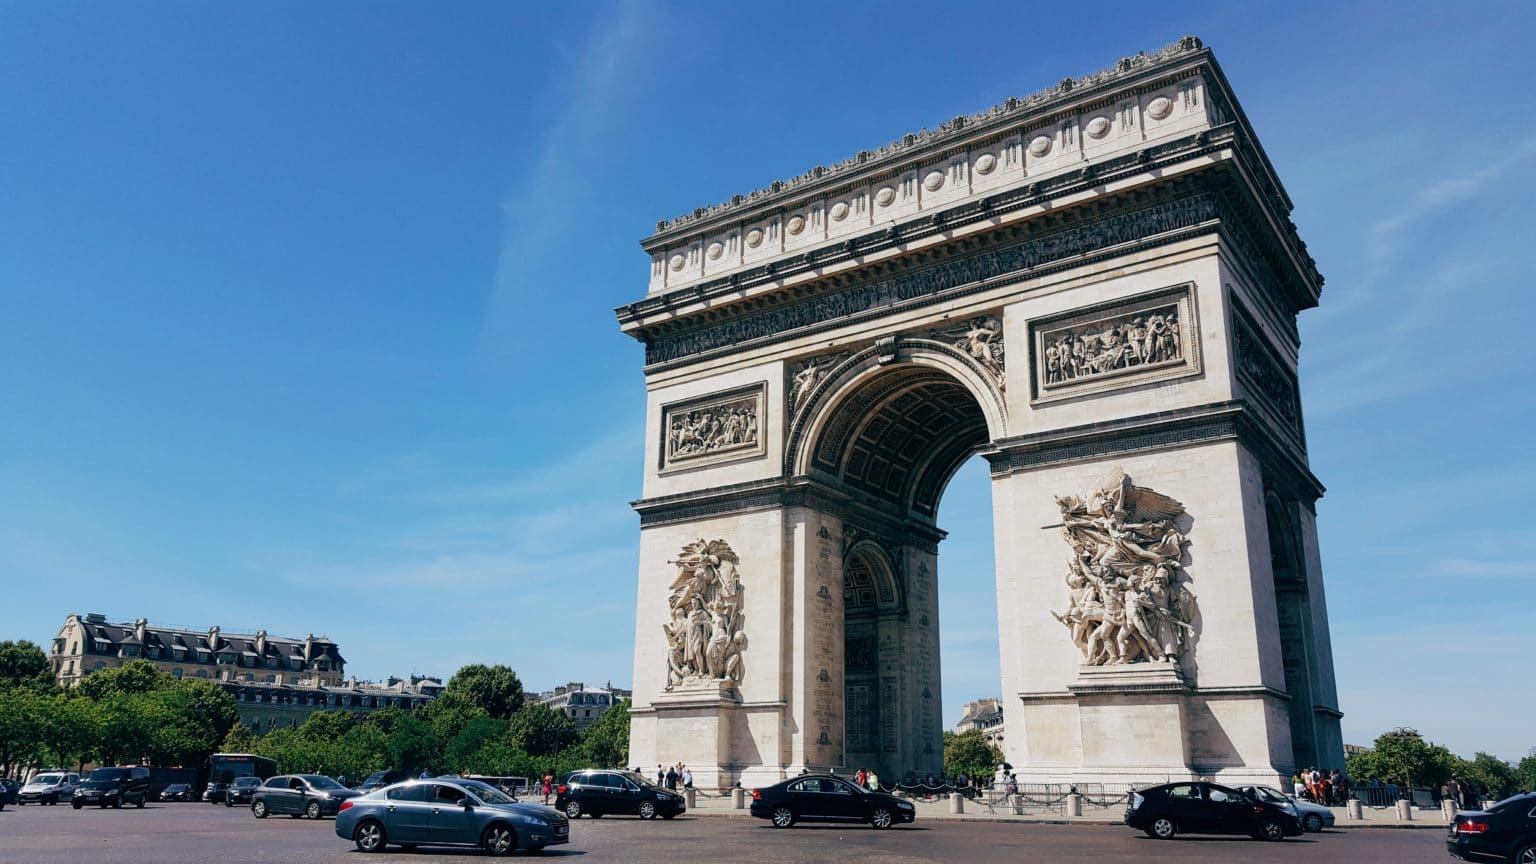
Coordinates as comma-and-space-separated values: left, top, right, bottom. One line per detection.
660, 383, 768, 470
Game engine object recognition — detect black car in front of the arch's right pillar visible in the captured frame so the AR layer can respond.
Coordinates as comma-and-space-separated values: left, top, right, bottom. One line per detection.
1126, 783, 1301, 839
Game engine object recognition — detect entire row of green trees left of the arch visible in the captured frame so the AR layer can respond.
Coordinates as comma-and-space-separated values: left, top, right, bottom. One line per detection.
0, 641, 630, 779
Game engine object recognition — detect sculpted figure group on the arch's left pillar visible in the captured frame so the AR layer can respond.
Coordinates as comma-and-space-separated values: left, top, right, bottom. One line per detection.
662, 538, 746, 690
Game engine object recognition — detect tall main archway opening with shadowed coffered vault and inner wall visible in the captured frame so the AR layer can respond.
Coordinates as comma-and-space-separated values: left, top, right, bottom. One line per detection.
808, 363, 998, 781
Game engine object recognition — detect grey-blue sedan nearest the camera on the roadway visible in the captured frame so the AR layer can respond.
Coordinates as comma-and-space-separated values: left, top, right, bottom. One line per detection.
336, 778, 570, 855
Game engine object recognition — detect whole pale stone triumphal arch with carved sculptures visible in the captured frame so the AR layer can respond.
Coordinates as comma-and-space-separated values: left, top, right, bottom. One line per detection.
617, 38, 1342, 787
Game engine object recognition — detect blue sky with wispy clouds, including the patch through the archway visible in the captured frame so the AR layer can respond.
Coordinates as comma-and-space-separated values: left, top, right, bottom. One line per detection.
0, 2, 1536, 758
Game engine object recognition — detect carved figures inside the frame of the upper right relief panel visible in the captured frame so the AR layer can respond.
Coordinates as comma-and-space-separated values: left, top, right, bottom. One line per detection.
1046, 307, 1183, 384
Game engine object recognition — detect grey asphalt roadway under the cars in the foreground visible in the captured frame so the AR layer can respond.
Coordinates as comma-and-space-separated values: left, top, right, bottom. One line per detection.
0, 804, 1448, 864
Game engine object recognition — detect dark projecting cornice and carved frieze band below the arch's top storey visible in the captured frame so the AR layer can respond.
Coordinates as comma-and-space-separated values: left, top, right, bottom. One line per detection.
616, 135, 1322, 369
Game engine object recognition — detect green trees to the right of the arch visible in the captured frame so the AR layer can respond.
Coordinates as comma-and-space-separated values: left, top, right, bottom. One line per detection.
1344, 729, 1536, 798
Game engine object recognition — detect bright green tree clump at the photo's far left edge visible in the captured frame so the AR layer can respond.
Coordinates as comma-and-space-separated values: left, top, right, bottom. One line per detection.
0, 641, 240, 775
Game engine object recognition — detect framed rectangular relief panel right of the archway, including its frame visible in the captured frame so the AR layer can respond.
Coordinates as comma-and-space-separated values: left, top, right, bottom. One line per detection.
1031, 286, 1200, 401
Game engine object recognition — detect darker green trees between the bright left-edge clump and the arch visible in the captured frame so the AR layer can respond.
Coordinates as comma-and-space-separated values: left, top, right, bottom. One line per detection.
235, 666, 630, 781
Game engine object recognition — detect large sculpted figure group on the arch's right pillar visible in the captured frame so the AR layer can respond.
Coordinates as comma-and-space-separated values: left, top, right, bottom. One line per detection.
1055, 470, 1193, 666
